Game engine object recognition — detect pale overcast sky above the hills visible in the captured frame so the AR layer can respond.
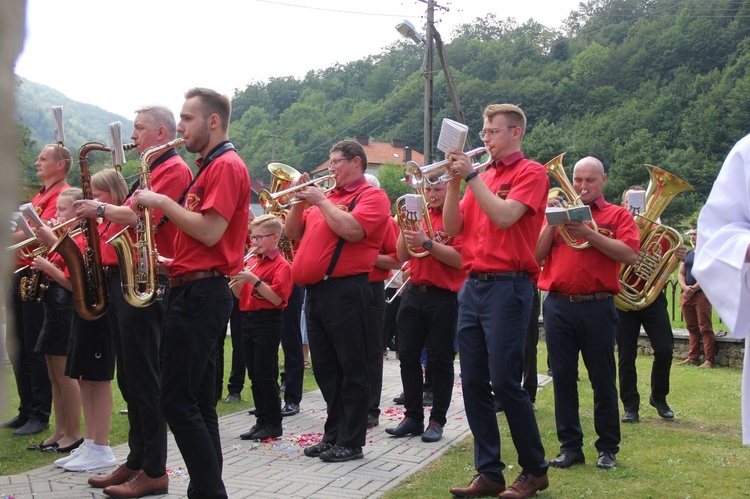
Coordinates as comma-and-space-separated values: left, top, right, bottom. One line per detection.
16, 0, 579, 119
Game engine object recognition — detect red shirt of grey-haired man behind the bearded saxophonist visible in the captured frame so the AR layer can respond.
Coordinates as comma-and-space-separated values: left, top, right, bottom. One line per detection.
123, 150, 193, 258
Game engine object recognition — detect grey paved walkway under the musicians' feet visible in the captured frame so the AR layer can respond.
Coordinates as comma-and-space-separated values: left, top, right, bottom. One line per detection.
0, 353, 549, 499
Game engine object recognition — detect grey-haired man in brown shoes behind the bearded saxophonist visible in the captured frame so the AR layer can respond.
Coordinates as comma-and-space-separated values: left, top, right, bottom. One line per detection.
75, 106, 193, 497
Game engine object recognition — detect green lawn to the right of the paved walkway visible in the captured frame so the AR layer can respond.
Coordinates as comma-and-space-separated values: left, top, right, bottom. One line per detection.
385, 343, 750, 499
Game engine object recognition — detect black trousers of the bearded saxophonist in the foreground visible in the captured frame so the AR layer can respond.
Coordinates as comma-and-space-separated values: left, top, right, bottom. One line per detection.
161, 277, 232, 498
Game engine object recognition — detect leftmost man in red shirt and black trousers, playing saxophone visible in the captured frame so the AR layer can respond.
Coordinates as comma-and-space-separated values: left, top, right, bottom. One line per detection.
0, 144, 73, 435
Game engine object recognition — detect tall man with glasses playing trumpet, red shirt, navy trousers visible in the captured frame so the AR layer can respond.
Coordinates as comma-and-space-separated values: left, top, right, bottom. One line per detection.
443, 104, 549, 497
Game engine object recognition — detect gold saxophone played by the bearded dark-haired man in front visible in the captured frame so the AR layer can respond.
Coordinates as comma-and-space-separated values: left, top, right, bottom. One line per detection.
107, 138, 185, 308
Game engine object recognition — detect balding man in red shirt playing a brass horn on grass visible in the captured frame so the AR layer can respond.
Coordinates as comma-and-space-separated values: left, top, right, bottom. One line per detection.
536, 157, 639, 469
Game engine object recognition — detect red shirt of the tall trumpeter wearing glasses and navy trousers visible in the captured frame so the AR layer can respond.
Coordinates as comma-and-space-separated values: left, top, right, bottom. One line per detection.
460, 151, 549, 279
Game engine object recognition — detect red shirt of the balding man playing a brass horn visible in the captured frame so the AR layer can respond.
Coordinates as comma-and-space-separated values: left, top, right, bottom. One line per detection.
539, 196, 639, 295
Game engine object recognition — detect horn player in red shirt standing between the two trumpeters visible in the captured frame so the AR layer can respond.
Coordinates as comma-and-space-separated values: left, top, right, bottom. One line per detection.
385, 172, 466, 442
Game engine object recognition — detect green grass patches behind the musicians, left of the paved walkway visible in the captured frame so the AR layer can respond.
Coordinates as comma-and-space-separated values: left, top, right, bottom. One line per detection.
0, 338, 318, 476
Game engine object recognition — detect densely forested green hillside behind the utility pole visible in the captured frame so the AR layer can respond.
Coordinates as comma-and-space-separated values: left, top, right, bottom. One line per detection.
230, 0, 750, 228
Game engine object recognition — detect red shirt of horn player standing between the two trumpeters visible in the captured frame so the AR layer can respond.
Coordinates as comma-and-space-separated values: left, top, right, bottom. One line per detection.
409, 208, 466, 293
